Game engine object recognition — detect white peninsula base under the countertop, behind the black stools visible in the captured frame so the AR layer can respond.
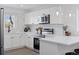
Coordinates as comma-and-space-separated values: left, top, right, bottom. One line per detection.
40, 40, 79, 55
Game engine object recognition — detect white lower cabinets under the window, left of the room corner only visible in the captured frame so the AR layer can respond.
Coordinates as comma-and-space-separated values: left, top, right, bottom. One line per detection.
4, 34, 26, 50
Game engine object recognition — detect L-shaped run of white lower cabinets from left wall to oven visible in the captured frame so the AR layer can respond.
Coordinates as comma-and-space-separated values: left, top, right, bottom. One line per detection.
4, 35, 33, 50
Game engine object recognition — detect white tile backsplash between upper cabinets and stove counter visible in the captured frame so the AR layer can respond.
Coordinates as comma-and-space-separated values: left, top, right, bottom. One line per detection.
26, 24, 64, 36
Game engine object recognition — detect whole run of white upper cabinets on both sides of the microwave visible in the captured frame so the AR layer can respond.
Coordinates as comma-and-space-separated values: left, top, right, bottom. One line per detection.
25, 7, 63, 24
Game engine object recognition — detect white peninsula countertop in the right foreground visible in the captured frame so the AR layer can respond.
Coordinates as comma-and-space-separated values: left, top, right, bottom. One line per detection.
40, 36, 79, 45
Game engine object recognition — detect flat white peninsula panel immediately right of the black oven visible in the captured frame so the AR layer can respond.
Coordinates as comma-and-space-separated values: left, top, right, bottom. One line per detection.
40, 41, 59, 55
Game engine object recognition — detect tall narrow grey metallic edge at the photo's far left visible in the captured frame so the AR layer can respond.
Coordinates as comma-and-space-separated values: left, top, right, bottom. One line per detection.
0, 8, 4, 55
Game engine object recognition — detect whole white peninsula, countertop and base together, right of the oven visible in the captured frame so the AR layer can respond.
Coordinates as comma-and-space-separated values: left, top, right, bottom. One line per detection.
40, 36, 79, 55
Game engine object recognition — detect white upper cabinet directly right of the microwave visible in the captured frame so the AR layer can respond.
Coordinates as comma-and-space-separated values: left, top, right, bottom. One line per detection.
50, 7, 63, 24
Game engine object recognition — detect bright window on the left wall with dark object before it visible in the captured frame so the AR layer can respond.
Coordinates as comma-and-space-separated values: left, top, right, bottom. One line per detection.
4, 15, 15, 32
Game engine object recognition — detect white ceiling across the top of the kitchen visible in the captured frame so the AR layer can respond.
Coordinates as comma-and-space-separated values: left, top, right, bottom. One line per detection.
0, 4, 78, 11
